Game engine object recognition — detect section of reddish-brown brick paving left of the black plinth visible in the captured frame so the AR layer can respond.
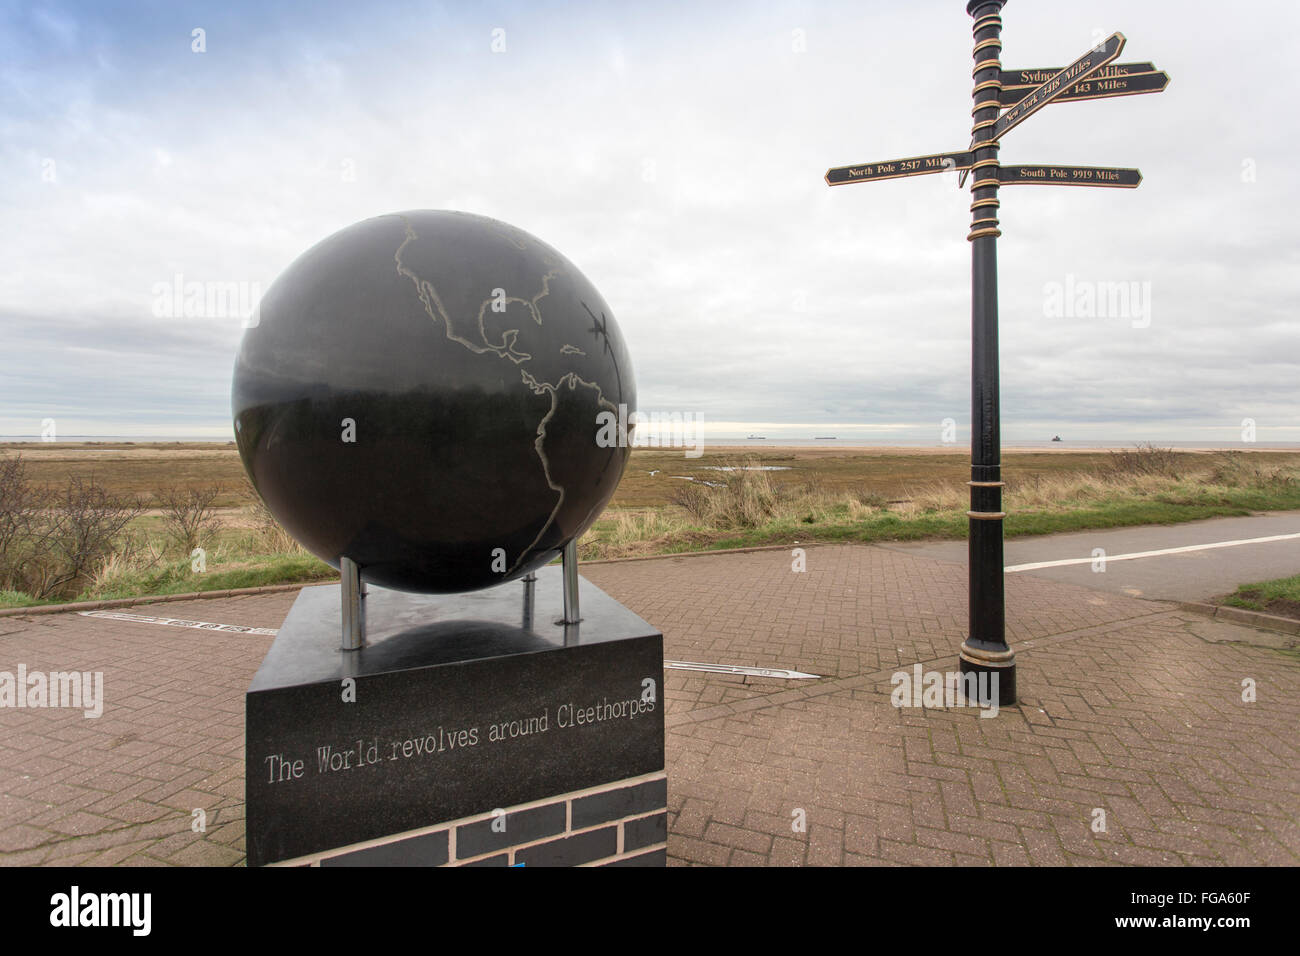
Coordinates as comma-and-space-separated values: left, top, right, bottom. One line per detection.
0, 592, 287, 865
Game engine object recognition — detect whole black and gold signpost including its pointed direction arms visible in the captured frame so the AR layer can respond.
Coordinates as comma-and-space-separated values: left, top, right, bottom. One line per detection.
826, 0, 1169, 706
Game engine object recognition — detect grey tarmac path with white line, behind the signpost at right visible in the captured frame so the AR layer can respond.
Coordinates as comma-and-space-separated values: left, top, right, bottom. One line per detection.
880, 511, 1300, 601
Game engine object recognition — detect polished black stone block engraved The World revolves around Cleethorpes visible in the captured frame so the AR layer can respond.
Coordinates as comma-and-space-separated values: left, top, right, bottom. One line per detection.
244, 566, 664, 866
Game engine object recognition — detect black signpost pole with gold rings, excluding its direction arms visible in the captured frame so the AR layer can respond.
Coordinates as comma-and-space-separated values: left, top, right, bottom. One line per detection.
959, 0, 1015, 706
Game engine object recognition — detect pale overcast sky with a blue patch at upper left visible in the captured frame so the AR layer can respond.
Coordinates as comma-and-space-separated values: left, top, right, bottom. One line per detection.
0, 0, 1300, 442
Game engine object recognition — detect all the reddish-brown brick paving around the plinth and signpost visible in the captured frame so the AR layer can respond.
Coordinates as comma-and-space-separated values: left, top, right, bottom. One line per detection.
0, 546, 1300, 865
